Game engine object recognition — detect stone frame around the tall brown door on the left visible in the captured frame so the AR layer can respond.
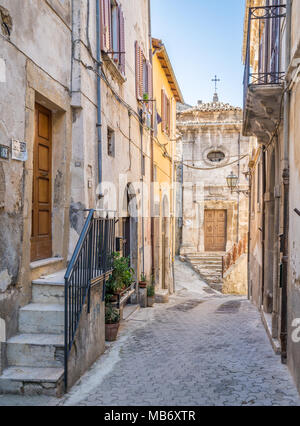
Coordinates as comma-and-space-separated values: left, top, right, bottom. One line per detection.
19, 61, 72, 300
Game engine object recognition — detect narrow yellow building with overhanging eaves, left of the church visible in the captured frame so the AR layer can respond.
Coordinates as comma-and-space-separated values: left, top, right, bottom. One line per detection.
152, 39, 183, 298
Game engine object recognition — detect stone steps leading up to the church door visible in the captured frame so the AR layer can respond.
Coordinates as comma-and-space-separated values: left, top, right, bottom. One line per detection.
184, 253, 224, 291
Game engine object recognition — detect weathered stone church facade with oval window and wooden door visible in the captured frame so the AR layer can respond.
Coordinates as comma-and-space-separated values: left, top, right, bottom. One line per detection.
177, 94, 249, 293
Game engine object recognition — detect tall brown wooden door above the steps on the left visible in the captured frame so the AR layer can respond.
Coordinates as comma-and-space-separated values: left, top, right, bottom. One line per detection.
31, 104, 52, 261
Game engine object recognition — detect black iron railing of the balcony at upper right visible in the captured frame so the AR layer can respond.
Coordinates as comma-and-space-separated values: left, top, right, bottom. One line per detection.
244, 0, 286, 110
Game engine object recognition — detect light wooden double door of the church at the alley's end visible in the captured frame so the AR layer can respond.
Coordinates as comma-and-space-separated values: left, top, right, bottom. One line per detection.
204, 210, 227, 251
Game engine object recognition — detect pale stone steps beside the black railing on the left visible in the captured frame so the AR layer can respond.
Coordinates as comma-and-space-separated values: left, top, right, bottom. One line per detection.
0, 271, 65, 397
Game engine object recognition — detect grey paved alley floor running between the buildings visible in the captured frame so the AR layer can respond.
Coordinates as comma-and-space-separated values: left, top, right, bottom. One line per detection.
0, 263, 300, 406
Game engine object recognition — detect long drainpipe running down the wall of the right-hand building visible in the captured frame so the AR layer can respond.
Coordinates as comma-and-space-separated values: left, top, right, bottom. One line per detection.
280, 0, 291, 364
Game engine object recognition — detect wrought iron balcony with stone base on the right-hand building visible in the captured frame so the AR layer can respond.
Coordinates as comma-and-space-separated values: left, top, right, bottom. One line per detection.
244, 0, 286, 143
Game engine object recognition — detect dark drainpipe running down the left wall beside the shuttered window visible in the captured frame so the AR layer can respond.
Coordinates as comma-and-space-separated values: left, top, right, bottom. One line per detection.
96, 0, 103, 190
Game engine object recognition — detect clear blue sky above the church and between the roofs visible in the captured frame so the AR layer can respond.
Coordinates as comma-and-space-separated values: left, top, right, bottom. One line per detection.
151, 0, 245, 106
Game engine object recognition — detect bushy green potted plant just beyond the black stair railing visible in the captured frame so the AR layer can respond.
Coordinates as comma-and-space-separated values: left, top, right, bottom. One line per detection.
106, 253, 134, 297
